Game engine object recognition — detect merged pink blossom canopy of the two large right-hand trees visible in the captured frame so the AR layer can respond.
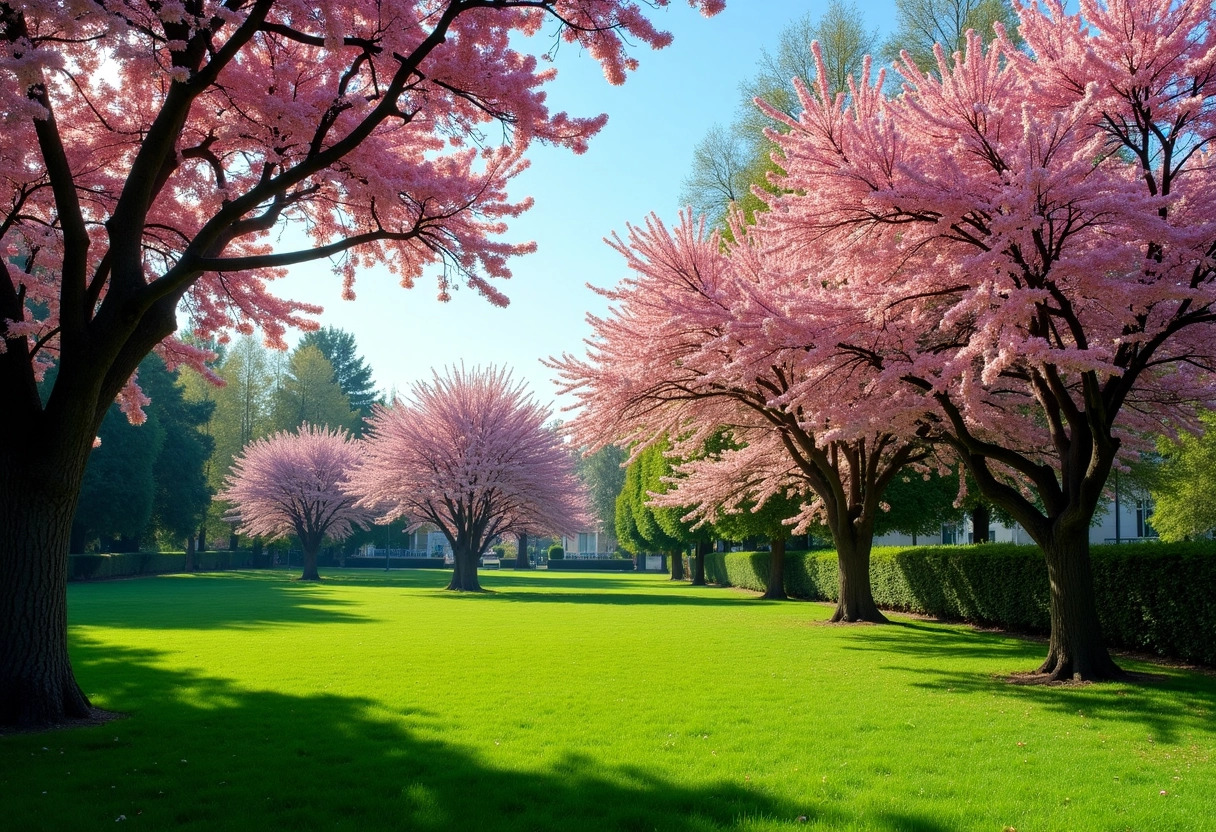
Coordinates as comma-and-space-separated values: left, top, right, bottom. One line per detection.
553, 0, 1216, 540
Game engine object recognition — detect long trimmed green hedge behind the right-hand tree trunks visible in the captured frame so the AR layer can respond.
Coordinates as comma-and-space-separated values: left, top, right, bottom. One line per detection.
705, 540, 1216, 664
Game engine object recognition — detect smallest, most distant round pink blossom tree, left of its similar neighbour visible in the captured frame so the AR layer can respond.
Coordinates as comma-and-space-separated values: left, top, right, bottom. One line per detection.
215, 425, 370, 580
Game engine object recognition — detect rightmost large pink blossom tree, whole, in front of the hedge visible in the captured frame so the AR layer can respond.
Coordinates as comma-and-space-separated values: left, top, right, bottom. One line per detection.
761, 0, 1216, 680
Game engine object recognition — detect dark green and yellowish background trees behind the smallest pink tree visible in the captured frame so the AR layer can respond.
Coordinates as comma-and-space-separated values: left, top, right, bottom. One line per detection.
72, 327, 377, 552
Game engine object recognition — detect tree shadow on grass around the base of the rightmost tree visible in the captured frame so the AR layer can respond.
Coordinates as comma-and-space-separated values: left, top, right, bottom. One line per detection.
849, 622, 1216, 742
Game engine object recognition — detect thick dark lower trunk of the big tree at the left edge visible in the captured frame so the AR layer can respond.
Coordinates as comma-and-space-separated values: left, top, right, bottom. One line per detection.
0, 447, 91, 727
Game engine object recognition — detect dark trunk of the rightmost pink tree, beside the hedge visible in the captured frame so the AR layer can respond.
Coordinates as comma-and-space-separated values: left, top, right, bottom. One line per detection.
1037, 524, 1125, 681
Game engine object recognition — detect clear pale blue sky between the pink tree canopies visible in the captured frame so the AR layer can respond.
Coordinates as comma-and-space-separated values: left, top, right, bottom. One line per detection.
275, 0, 894, 406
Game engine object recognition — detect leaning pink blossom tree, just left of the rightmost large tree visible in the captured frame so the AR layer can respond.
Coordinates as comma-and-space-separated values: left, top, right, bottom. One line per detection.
548, 212, 929, 622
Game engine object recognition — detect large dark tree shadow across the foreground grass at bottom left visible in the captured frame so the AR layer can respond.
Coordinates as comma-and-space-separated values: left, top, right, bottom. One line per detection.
0, 640, 856, 832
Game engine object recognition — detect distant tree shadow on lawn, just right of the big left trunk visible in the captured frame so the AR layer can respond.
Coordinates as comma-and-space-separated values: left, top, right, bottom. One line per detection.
68, 572, 375, 630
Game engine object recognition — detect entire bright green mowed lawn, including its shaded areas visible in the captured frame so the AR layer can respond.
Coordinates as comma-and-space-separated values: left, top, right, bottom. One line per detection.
0, 570, 1216, 832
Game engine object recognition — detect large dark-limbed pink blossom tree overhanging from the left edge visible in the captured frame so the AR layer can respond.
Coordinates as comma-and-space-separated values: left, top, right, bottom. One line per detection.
0, 0, 724, 724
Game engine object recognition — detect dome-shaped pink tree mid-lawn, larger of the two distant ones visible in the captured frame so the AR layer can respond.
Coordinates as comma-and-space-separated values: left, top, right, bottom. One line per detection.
348, 367, 590, 591
